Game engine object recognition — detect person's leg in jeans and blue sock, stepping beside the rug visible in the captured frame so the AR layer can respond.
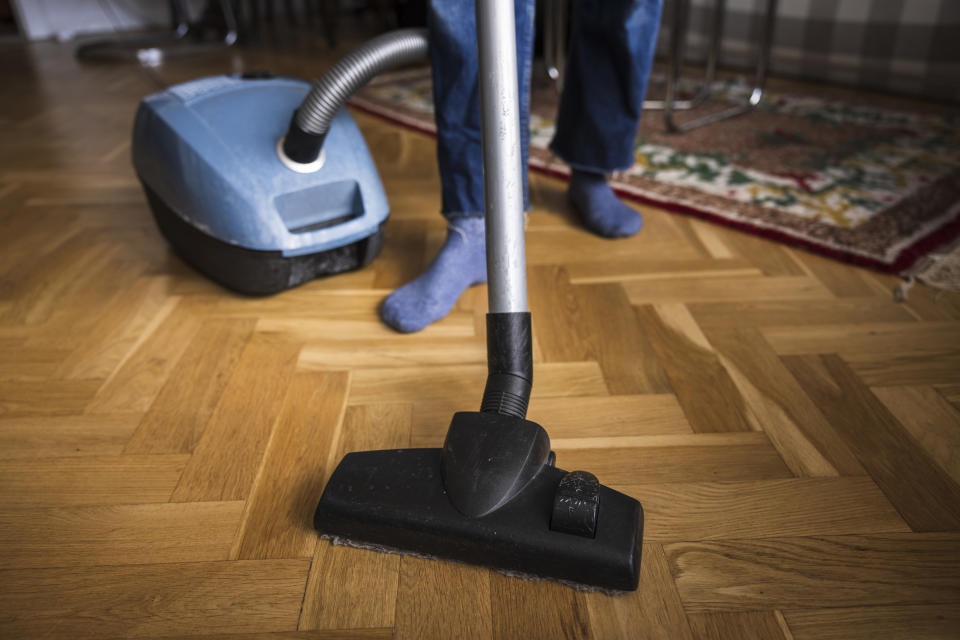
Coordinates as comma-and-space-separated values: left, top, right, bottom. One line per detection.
550, 0, 662, 238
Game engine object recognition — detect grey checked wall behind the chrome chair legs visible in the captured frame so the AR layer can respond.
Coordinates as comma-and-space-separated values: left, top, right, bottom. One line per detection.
672, 0, 960, 100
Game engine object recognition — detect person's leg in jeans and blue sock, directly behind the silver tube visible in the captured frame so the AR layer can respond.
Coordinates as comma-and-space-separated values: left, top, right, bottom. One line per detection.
381, 0, 534, 333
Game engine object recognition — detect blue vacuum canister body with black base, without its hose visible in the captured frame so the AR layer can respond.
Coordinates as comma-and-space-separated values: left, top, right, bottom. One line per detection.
133, 73, 389, 295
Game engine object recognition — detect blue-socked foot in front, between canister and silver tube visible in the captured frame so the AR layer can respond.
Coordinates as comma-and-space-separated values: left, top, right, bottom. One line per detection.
380, 218, 487, 333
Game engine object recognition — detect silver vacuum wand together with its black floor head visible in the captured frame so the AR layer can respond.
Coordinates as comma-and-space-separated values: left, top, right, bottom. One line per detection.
314, 0, 643, 590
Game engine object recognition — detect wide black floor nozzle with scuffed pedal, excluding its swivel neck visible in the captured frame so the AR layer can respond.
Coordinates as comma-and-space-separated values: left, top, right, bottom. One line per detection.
314, 444, 643, 590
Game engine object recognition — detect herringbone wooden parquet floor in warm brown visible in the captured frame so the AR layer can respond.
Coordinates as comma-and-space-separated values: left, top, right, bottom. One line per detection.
0, 36, 960, 640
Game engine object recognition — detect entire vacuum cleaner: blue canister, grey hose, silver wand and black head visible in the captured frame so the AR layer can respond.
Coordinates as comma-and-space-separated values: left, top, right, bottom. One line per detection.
133, 0, 643, 590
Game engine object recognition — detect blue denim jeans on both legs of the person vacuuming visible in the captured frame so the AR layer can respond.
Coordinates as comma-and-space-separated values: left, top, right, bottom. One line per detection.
429, 0, 662, 220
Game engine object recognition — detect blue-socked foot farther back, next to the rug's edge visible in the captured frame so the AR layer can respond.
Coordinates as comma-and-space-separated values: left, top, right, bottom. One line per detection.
567, 169, 643, 238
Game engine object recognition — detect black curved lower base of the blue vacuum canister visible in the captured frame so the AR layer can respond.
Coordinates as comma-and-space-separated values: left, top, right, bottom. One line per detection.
143, 184, 385, 296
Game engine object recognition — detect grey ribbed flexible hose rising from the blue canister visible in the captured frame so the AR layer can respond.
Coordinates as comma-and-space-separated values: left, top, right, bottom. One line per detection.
296, 29, 427, 136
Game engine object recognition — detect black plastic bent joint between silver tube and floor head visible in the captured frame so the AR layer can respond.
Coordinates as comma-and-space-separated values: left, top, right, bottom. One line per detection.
480, 311, 533, 418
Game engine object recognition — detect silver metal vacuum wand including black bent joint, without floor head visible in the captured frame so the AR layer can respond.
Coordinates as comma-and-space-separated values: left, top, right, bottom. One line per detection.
476, 0, 533, 418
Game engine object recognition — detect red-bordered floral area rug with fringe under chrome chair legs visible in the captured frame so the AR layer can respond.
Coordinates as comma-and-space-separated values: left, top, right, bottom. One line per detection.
351, 69, 960, 273
